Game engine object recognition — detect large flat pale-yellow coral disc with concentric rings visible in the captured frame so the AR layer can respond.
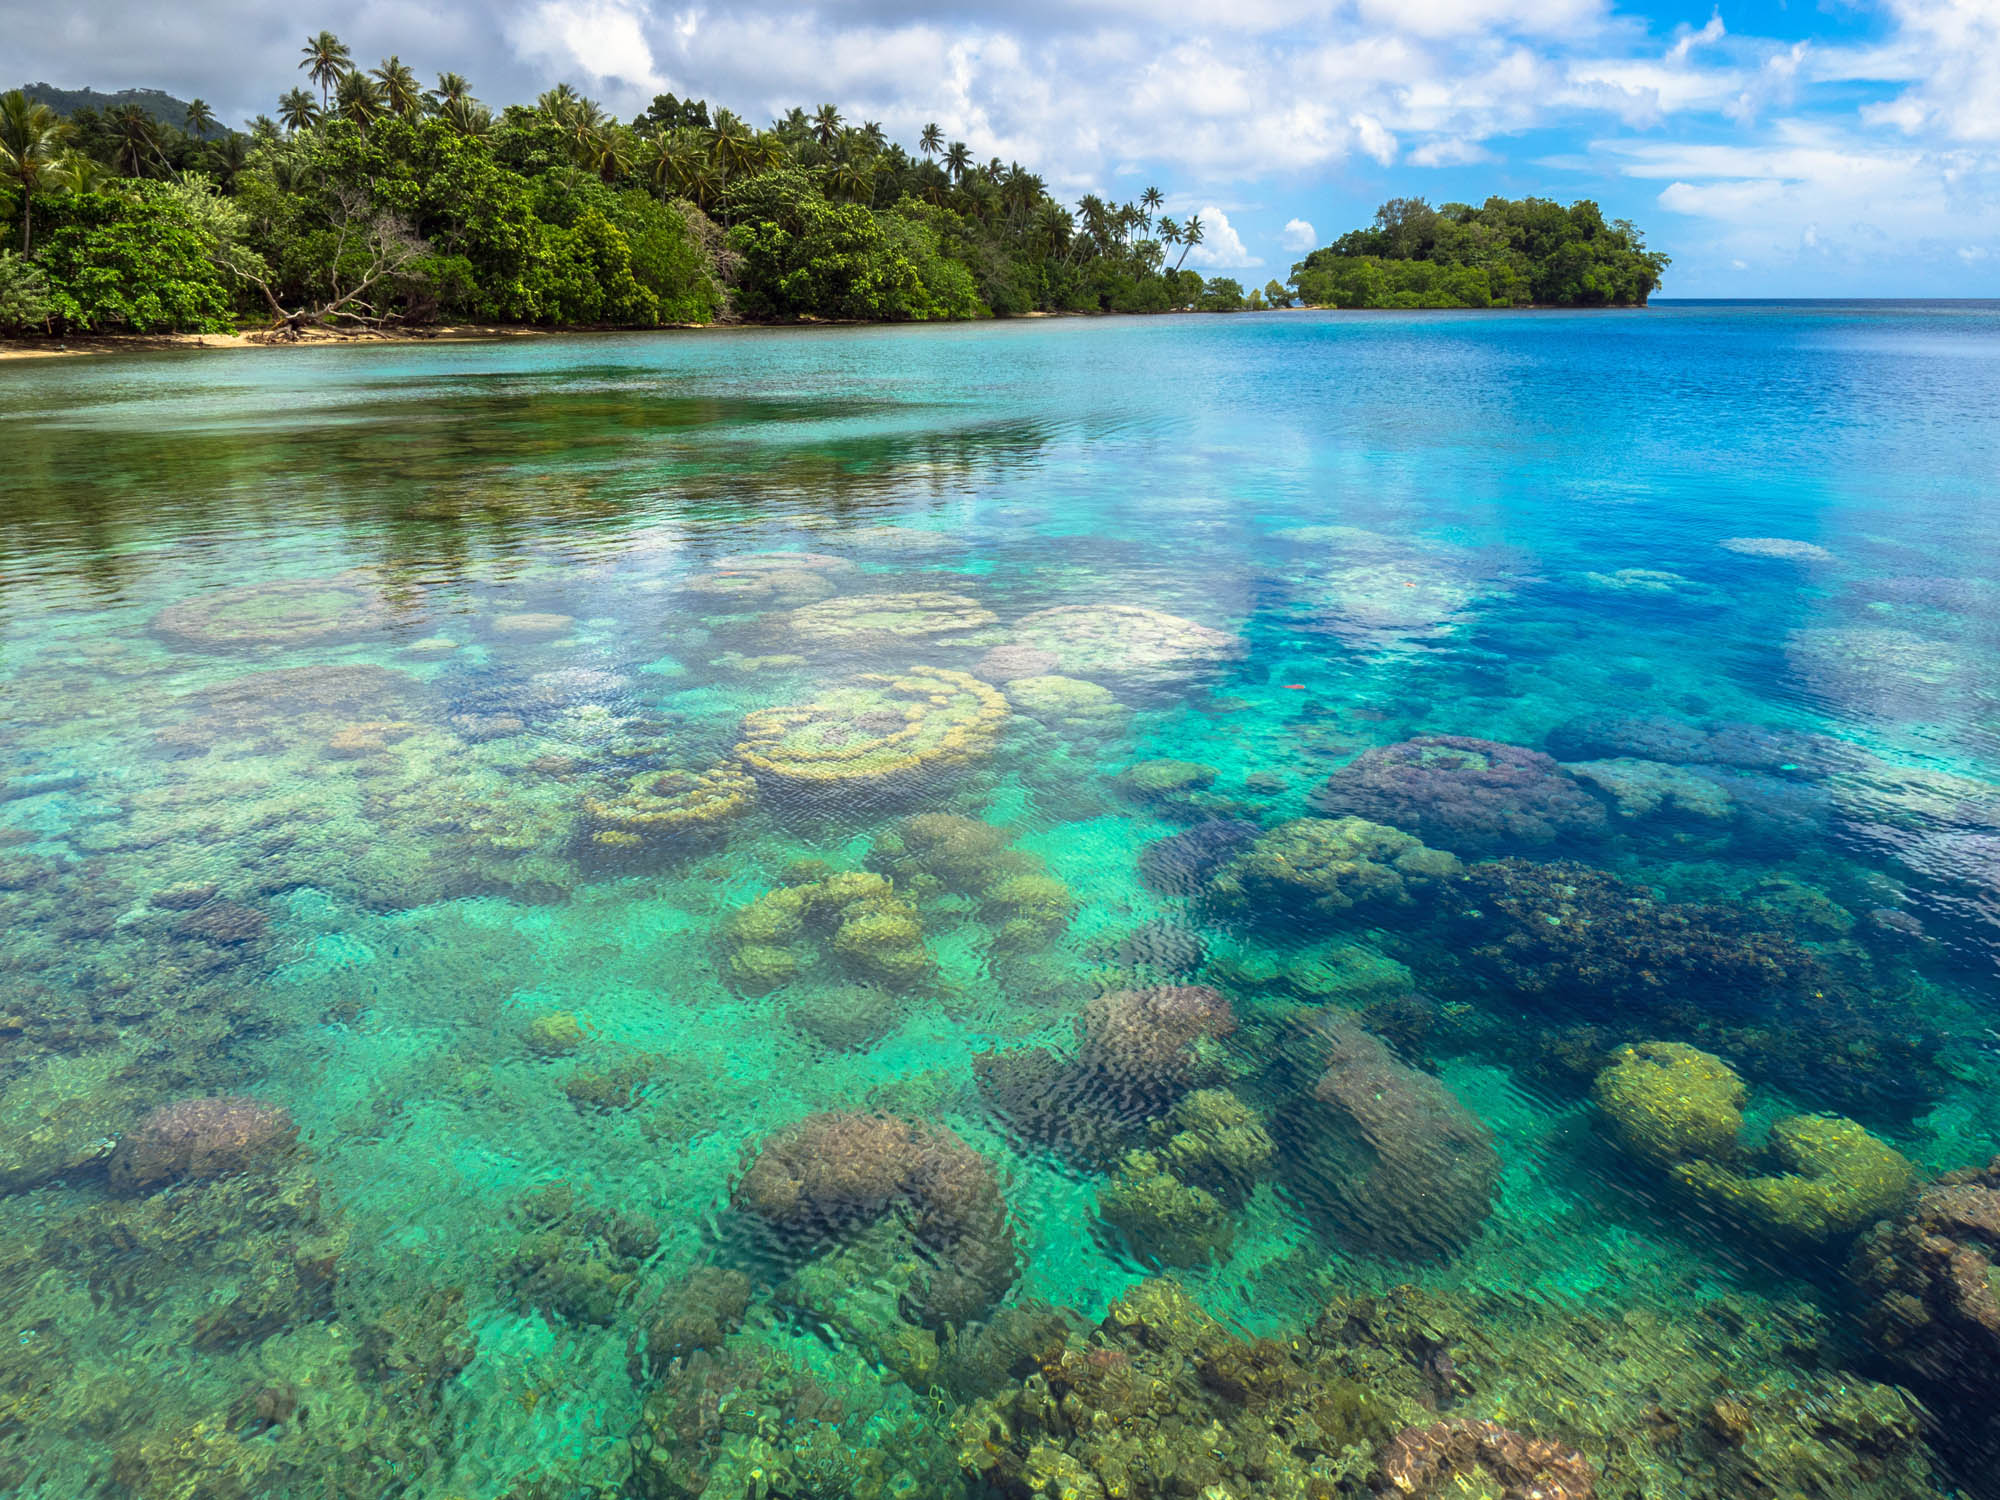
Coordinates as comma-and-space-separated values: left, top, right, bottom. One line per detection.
736, 666, 1008, 798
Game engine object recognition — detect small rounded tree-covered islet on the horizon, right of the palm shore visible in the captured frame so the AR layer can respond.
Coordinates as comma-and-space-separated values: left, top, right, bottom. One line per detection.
1292, 198, 1668, 308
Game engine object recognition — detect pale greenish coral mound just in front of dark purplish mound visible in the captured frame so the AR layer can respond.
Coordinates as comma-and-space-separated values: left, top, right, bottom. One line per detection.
1210, 818, 1464, 922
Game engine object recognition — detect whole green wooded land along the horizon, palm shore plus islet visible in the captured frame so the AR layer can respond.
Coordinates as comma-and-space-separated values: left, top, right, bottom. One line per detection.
0, 32, 1666, 338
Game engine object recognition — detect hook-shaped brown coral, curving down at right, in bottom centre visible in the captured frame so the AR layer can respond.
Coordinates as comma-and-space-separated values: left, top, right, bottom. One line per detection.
730, 1114, 1018, 1328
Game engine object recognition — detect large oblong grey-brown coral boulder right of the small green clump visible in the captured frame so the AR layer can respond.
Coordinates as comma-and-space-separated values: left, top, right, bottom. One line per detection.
1276, 1018, 1500, 1260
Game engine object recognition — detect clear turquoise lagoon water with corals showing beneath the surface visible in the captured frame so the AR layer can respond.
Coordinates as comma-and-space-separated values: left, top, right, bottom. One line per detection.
0, 304, 2000, 1500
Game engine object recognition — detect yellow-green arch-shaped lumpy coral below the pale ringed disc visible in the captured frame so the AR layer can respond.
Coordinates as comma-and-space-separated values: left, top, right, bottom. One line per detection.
726, 870, 936, 994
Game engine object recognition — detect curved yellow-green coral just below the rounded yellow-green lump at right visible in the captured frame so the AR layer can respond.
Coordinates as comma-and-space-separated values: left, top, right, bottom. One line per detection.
1676, 1114, 1916, 1244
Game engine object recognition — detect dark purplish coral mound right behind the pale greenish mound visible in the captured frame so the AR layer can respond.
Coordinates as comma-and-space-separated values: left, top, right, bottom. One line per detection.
1308, 734, 1606, 854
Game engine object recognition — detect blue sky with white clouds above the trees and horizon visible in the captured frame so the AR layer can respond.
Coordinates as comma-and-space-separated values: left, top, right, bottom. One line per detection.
15, 0, 2000, 296
